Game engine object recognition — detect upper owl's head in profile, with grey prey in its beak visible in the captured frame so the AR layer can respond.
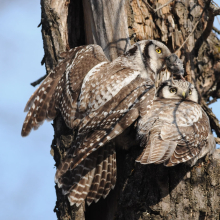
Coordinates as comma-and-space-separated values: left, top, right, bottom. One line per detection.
125, 40, 184, 84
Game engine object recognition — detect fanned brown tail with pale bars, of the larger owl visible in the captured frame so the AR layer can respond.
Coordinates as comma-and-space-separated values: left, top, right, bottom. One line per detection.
55, 143, 117, 206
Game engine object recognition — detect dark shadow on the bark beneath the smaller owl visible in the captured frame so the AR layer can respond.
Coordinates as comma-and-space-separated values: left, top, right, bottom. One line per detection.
85, 144, 191, 220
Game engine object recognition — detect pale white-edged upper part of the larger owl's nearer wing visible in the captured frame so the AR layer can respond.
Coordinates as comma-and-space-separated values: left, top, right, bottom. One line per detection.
79, 57, 144, 114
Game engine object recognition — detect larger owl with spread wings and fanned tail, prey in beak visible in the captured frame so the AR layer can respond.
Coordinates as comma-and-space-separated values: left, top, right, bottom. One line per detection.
22, 40, 183, 205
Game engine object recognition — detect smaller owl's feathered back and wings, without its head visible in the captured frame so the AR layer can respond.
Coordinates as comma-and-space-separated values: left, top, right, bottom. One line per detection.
137, 100, 213, 166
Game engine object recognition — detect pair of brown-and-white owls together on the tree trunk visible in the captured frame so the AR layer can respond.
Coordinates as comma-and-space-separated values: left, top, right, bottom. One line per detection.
22, 40, 215, 206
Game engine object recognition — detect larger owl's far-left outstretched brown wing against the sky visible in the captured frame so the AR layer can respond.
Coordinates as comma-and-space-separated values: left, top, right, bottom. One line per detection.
21, 45, 109, 136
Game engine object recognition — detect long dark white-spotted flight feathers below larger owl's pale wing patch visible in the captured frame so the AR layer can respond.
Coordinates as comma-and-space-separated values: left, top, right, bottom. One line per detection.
62, 77, 153, 170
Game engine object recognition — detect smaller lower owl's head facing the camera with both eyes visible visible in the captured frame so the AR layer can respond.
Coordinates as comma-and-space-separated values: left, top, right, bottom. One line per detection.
156, 80, 199, 103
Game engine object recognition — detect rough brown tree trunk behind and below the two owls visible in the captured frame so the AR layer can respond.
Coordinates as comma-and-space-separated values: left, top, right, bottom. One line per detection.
41, 0, 220, 220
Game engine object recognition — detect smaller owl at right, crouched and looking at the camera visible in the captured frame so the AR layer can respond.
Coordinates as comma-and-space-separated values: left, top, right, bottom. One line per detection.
136, 80, 216, 166
